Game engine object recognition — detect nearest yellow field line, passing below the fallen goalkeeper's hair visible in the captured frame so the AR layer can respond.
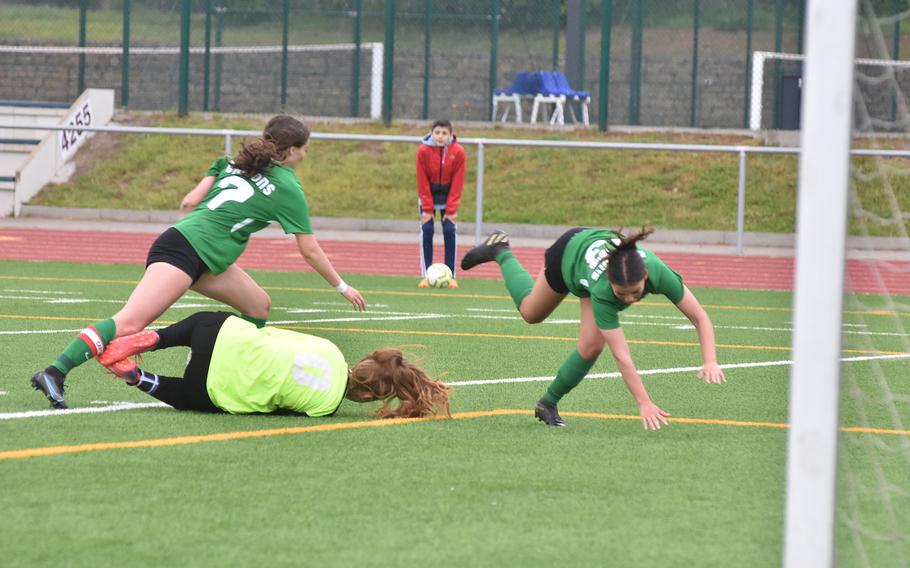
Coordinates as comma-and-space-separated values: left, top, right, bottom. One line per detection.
0, 408, 910, 461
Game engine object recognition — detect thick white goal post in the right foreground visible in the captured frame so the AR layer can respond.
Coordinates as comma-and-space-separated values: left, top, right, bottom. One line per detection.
788, 0, 857, 568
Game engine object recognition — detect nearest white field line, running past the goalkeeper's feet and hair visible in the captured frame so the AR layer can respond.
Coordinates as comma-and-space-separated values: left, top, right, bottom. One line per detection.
0, 354, 910, 420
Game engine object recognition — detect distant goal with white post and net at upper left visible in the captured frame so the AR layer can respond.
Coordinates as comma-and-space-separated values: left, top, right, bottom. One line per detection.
0, 42, 383, 119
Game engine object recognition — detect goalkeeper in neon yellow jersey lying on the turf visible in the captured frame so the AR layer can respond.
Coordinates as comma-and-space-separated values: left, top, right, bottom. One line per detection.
98, 312, 449, 418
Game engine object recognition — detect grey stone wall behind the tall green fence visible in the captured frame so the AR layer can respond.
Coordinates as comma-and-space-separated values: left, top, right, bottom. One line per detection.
0, 49, 910, 128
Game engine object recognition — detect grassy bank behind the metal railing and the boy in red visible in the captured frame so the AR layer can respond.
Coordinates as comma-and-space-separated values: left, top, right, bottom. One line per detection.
31, 115, 910, 236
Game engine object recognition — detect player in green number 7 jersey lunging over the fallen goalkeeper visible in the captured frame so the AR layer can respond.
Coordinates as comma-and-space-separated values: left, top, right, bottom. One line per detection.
31, 115, 366, 408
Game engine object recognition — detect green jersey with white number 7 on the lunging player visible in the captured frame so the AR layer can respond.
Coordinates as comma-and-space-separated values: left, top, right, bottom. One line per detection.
174, 157, 313, 274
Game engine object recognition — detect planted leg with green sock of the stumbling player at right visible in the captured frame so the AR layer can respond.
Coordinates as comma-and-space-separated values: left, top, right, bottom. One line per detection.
534, 298, 605, 426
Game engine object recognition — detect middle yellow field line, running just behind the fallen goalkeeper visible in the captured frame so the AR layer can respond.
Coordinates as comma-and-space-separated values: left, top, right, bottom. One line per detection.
0, 314, 904, 355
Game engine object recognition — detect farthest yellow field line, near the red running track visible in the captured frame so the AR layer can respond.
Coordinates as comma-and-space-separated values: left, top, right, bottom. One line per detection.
0, 276, 910, 317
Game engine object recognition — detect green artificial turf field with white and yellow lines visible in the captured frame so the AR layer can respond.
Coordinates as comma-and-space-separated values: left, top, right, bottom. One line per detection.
0, 261, 910, 566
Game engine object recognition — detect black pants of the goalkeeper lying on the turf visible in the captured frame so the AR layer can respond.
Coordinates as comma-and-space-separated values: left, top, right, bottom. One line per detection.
143, 312, 232, 412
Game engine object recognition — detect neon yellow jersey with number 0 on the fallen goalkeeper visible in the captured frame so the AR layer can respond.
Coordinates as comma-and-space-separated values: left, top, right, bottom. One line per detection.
206, 316, 348, 416
